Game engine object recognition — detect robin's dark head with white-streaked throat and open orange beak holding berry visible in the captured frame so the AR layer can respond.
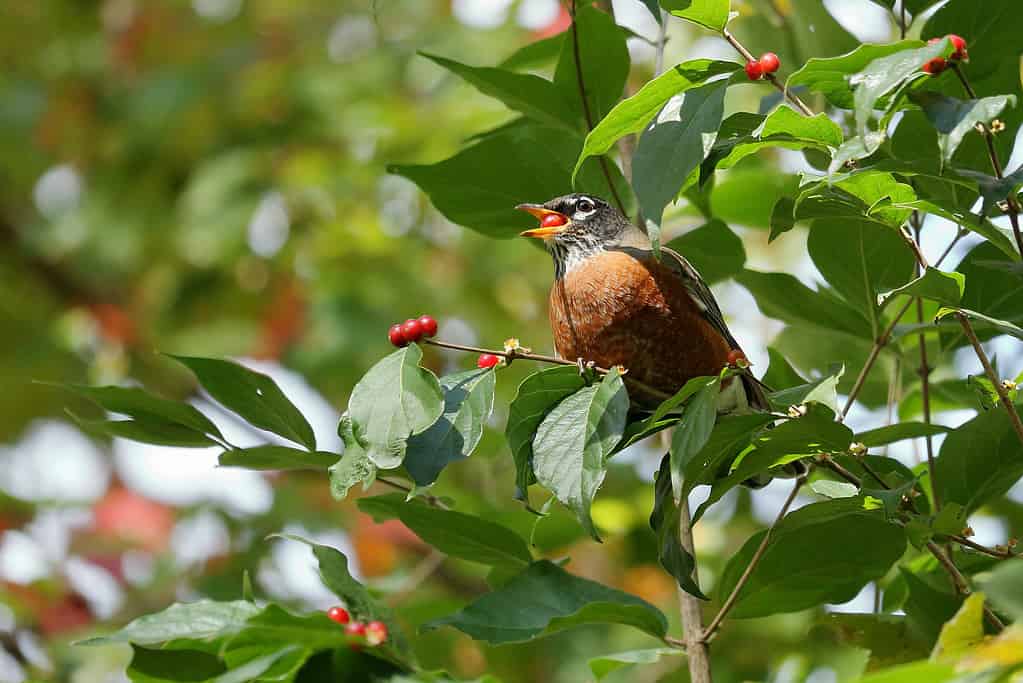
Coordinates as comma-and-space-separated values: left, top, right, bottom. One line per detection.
516, 193, 642, 274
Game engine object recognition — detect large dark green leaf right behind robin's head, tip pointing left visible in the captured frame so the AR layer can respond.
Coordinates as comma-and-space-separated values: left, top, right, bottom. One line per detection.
388, 123, 630, 238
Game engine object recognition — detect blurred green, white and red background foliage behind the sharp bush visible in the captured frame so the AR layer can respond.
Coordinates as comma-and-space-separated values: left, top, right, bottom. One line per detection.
0, 0, 1023, 683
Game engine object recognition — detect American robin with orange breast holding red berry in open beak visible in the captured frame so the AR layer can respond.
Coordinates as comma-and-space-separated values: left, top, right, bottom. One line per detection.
517, 194, 769, 412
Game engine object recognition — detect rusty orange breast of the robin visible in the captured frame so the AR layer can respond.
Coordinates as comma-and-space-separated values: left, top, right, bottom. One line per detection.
550, 252, 729, 400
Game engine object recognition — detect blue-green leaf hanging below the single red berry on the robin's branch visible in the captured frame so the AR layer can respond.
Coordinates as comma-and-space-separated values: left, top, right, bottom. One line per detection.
404, 369, 496, 486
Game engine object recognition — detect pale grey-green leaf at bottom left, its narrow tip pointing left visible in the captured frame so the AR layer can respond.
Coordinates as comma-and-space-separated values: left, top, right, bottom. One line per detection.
79, 600, 260, 645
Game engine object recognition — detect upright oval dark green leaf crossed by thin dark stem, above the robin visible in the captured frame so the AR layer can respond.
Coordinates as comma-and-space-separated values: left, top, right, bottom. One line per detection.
550, 5, 629, 125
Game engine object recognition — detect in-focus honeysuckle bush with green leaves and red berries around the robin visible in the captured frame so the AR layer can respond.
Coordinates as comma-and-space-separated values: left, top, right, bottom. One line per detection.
61, 0, 1023, 683
